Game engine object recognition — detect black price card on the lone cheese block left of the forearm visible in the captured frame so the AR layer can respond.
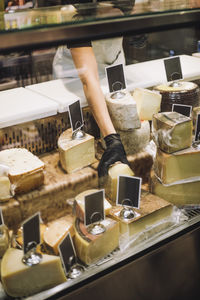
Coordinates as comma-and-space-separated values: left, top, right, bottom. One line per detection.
69, 100, 83, 132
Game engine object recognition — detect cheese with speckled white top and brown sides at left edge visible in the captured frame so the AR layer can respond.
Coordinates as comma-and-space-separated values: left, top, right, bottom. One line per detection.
0, 148, 44, 194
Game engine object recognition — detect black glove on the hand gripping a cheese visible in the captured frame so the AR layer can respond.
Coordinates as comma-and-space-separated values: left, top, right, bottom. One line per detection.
98, 133, 129, 177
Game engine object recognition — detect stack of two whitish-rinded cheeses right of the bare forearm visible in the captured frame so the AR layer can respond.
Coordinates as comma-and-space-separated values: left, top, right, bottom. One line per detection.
105, 90, 150, 155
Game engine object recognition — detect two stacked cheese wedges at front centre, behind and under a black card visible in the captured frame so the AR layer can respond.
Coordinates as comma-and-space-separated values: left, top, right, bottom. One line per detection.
74, 190, 119, 265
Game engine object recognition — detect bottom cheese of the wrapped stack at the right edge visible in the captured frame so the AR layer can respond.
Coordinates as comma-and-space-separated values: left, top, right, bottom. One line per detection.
151, 176, 200, 206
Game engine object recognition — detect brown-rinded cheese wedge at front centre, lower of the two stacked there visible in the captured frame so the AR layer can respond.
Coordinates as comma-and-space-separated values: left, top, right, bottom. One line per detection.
74, 218, 119, 265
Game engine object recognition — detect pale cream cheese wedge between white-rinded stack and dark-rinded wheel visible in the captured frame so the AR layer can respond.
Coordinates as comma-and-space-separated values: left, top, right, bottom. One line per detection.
133, 88, 162, 120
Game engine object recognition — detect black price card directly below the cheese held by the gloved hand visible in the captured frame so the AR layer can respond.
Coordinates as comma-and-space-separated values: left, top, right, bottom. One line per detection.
116, 176, 142, 208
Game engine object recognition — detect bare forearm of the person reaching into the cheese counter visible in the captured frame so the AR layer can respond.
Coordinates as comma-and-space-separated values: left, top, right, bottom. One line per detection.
71, 47, 116, 136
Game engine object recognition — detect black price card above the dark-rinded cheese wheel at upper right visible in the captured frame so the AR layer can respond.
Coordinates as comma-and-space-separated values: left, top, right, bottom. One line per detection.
164, 56, 183, 81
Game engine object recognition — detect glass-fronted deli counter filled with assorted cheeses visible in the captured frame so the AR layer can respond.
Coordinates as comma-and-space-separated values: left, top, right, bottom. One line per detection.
0, 0, 200, 300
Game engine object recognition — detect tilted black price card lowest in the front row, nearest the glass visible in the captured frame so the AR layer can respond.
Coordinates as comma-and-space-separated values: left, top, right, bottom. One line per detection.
58, 233, 76, 274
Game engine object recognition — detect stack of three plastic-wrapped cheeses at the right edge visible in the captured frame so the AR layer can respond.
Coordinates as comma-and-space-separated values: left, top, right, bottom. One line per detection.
151, 112, 200, 206
